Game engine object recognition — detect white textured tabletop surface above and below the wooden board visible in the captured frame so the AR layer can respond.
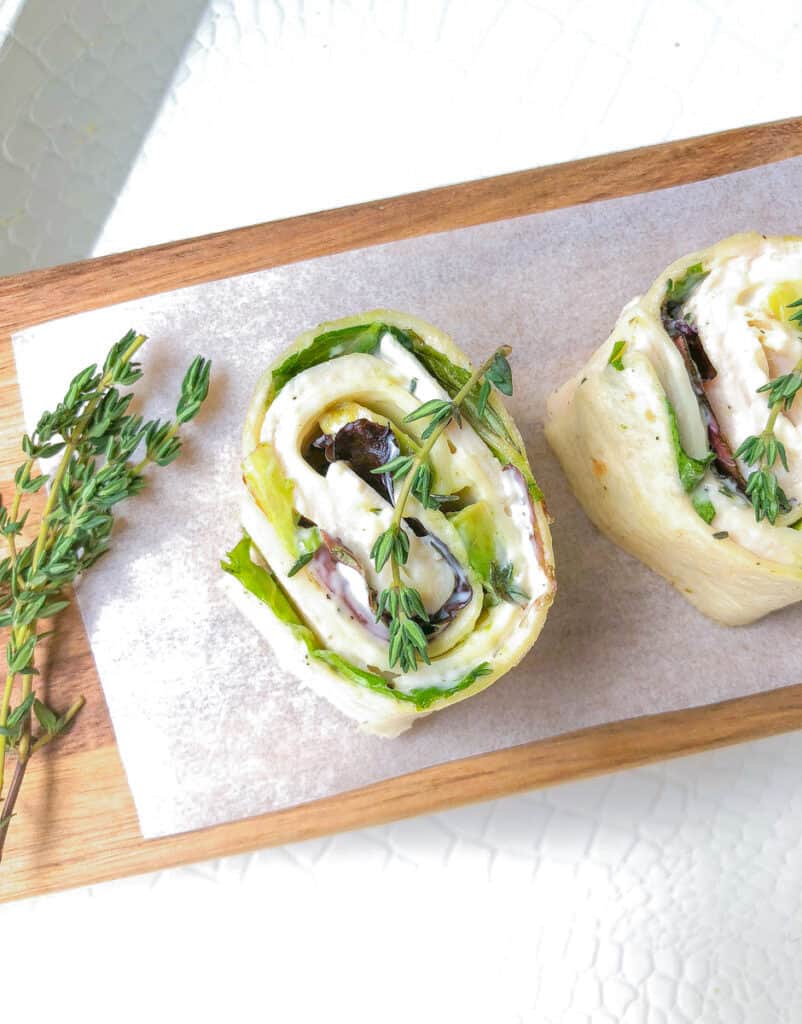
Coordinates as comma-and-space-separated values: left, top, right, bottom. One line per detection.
0, 0, 802, 1024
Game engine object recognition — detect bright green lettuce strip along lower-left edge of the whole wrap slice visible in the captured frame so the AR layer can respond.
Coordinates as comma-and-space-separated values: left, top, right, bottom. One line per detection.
220, 534, 491, 711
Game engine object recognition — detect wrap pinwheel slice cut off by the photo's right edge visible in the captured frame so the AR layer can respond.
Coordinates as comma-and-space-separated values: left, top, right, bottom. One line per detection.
546, 233, 802, 626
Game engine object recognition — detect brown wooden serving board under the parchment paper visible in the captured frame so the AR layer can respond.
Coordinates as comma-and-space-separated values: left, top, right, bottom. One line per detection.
0, 119, 802, 900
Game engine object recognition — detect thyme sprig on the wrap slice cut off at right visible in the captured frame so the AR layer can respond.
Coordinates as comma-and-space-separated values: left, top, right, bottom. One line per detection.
735, 348, 802, 526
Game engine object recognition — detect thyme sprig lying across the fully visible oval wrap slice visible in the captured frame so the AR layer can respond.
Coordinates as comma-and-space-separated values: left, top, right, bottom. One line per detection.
371, 345, 512, 672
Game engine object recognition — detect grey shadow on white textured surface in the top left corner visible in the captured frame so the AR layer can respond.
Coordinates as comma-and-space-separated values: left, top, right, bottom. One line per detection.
0, 0, 208, 274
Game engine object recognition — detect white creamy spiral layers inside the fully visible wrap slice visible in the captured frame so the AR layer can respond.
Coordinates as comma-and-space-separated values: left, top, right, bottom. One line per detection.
250, 333, 550, 692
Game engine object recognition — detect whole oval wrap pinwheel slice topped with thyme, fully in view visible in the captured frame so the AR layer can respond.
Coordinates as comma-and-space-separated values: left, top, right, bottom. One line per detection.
223, 310, 555, 736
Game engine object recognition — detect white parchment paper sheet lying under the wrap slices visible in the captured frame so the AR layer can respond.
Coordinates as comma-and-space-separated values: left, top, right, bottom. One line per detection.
14, 153, 802, 838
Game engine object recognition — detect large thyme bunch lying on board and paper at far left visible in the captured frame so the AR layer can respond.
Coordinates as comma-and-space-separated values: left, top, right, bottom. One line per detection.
0, 331, 211, 857
